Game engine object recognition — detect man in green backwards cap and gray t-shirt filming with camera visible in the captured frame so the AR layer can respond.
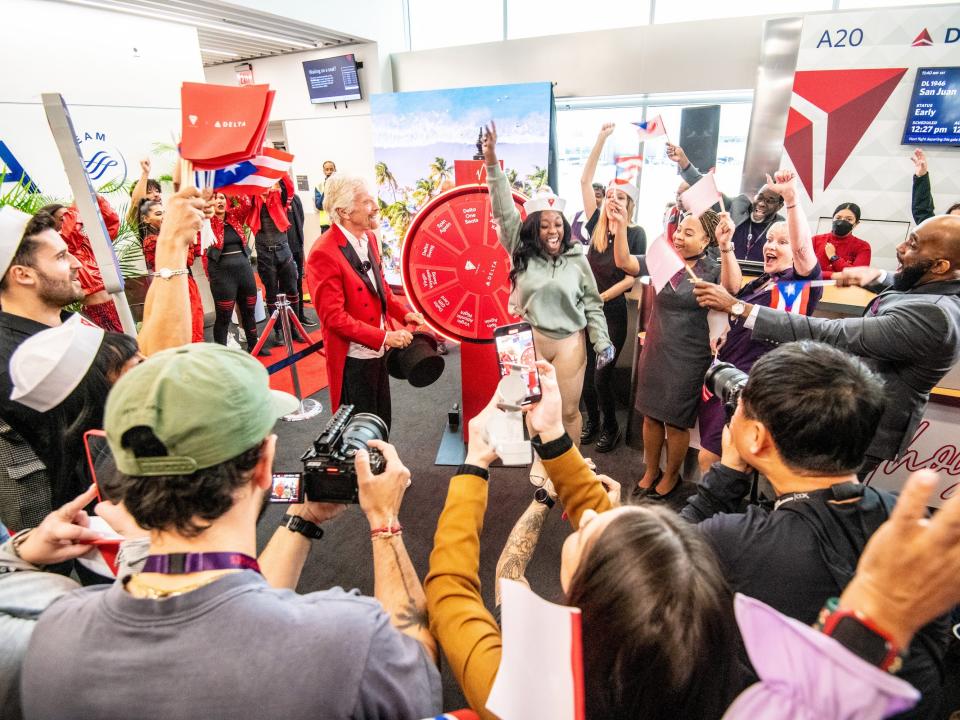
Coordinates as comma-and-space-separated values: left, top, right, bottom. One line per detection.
21, 343, 440, 720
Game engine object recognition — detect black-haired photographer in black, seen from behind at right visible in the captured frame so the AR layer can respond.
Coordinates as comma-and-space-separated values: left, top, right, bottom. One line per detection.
680, 341, 948, 718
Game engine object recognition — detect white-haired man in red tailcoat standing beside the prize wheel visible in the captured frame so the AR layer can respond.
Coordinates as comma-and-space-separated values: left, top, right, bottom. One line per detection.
307, 175, 423, 427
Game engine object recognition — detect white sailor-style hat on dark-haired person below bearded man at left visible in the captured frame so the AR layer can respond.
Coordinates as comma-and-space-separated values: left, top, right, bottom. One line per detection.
10, 315, 104, 412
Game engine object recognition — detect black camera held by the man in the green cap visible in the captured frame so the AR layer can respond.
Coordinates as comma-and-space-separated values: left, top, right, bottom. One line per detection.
300, 405, 389, 503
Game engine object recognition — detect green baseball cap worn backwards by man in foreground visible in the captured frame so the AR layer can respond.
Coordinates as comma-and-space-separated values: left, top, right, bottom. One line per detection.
103, 343, 300, 476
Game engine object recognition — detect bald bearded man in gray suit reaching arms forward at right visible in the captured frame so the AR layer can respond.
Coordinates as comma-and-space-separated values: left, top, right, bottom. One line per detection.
694, 215, 960, 479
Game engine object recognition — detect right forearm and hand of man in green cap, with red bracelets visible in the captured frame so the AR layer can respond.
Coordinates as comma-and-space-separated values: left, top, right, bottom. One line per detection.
356, 440, 438, 661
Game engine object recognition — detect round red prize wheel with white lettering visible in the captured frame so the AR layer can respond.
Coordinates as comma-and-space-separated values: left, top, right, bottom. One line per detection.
401, 185, 525, 343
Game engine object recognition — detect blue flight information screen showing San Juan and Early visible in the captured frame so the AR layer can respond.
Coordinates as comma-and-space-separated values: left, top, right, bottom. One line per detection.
901, 67, 960, 145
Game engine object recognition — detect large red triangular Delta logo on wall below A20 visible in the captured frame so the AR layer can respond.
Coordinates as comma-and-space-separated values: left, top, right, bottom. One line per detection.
783, 68, 907, 199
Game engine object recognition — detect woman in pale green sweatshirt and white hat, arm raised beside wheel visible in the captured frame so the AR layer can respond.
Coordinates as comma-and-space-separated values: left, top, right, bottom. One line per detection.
483, 122, 614, 483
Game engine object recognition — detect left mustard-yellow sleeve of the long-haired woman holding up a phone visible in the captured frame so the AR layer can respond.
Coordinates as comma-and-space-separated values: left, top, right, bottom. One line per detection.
423, 475, 502, 720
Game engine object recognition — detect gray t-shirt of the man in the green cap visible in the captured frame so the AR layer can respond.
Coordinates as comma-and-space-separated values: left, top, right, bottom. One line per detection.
21, 570, 441, 720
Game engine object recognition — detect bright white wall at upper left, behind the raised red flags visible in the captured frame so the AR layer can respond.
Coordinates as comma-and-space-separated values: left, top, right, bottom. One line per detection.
0, 0, 203, 198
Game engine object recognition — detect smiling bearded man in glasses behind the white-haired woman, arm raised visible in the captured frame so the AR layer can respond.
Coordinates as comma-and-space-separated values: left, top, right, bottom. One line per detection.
667, 143, 789, 262
